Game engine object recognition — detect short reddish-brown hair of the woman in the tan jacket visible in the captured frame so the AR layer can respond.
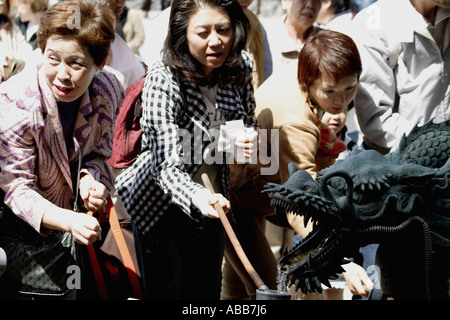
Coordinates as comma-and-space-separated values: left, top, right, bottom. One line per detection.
297, 30, 362, 92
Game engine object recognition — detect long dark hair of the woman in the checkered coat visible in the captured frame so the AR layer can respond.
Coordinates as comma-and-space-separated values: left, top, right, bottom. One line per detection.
163, 0, 249, 83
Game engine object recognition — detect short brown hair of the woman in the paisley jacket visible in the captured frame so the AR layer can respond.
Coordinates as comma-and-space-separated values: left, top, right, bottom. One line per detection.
37, 0, 115, 67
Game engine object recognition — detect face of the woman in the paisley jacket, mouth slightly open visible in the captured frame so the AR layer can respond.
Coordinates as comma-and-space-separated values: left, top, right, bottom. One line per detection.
43, 35, 97, 102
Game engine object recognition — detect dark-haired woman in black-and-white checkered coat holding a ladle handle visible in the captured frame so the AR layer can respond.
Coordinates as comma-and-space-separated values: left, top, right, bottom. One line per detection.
116, 0, 257, 299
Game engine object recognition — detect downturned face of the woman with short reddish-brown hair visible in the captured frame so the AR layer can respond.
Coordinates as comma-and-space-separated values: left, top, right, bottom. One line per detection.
309, 75, 358, 114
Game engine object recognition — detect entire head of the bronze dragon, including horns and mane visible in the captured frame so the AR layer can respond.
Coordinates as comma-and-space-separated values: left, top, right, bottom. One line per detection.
264, 150, 437, 293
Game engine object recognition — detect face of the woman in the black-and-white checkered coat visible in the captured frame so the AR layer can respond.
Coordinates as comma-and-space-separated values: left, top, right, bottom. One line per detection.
186, 7, 233, 75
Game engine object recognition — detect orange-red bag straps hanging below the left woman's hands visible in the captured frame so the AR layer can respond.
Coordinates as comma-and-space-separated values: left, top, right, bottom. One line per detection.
88, 196, 143, 300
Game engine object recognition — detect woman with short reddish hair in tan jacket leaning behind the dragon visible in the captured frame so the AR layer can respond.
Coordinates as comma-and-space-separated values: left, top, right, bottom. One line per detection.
232, 30, 372, 295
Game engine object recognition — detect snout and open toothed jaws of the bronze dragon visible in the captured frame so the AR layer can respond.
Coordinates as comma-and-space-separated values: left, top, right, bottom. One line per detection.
264, 163, 356, 293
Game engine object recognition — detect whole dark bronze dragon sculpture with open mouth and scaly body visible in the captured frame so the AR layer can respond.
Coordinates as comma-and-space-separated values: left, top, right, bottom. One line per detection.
264, 120, 450, 299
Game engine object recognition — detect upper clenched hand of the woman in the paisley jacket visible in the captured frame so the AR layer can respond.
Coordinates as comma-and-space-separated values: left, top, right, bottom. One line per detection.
80, 174, 106, 212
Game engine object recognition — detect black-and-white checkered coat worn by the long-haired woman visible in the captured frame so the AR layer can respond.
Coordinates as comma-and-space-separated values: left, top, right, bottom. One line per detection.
116, 52, 257, 234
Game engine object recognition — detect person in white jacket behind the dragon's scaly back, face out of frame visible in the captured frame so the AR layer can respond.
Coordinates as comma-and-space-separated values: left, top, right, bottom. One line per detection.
350, 0, 450, 154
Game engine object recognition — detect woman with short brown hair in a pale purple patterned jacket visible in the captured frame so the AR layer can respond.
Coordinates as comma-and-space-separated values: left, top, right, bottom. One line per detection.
0, 0, 123, 299
